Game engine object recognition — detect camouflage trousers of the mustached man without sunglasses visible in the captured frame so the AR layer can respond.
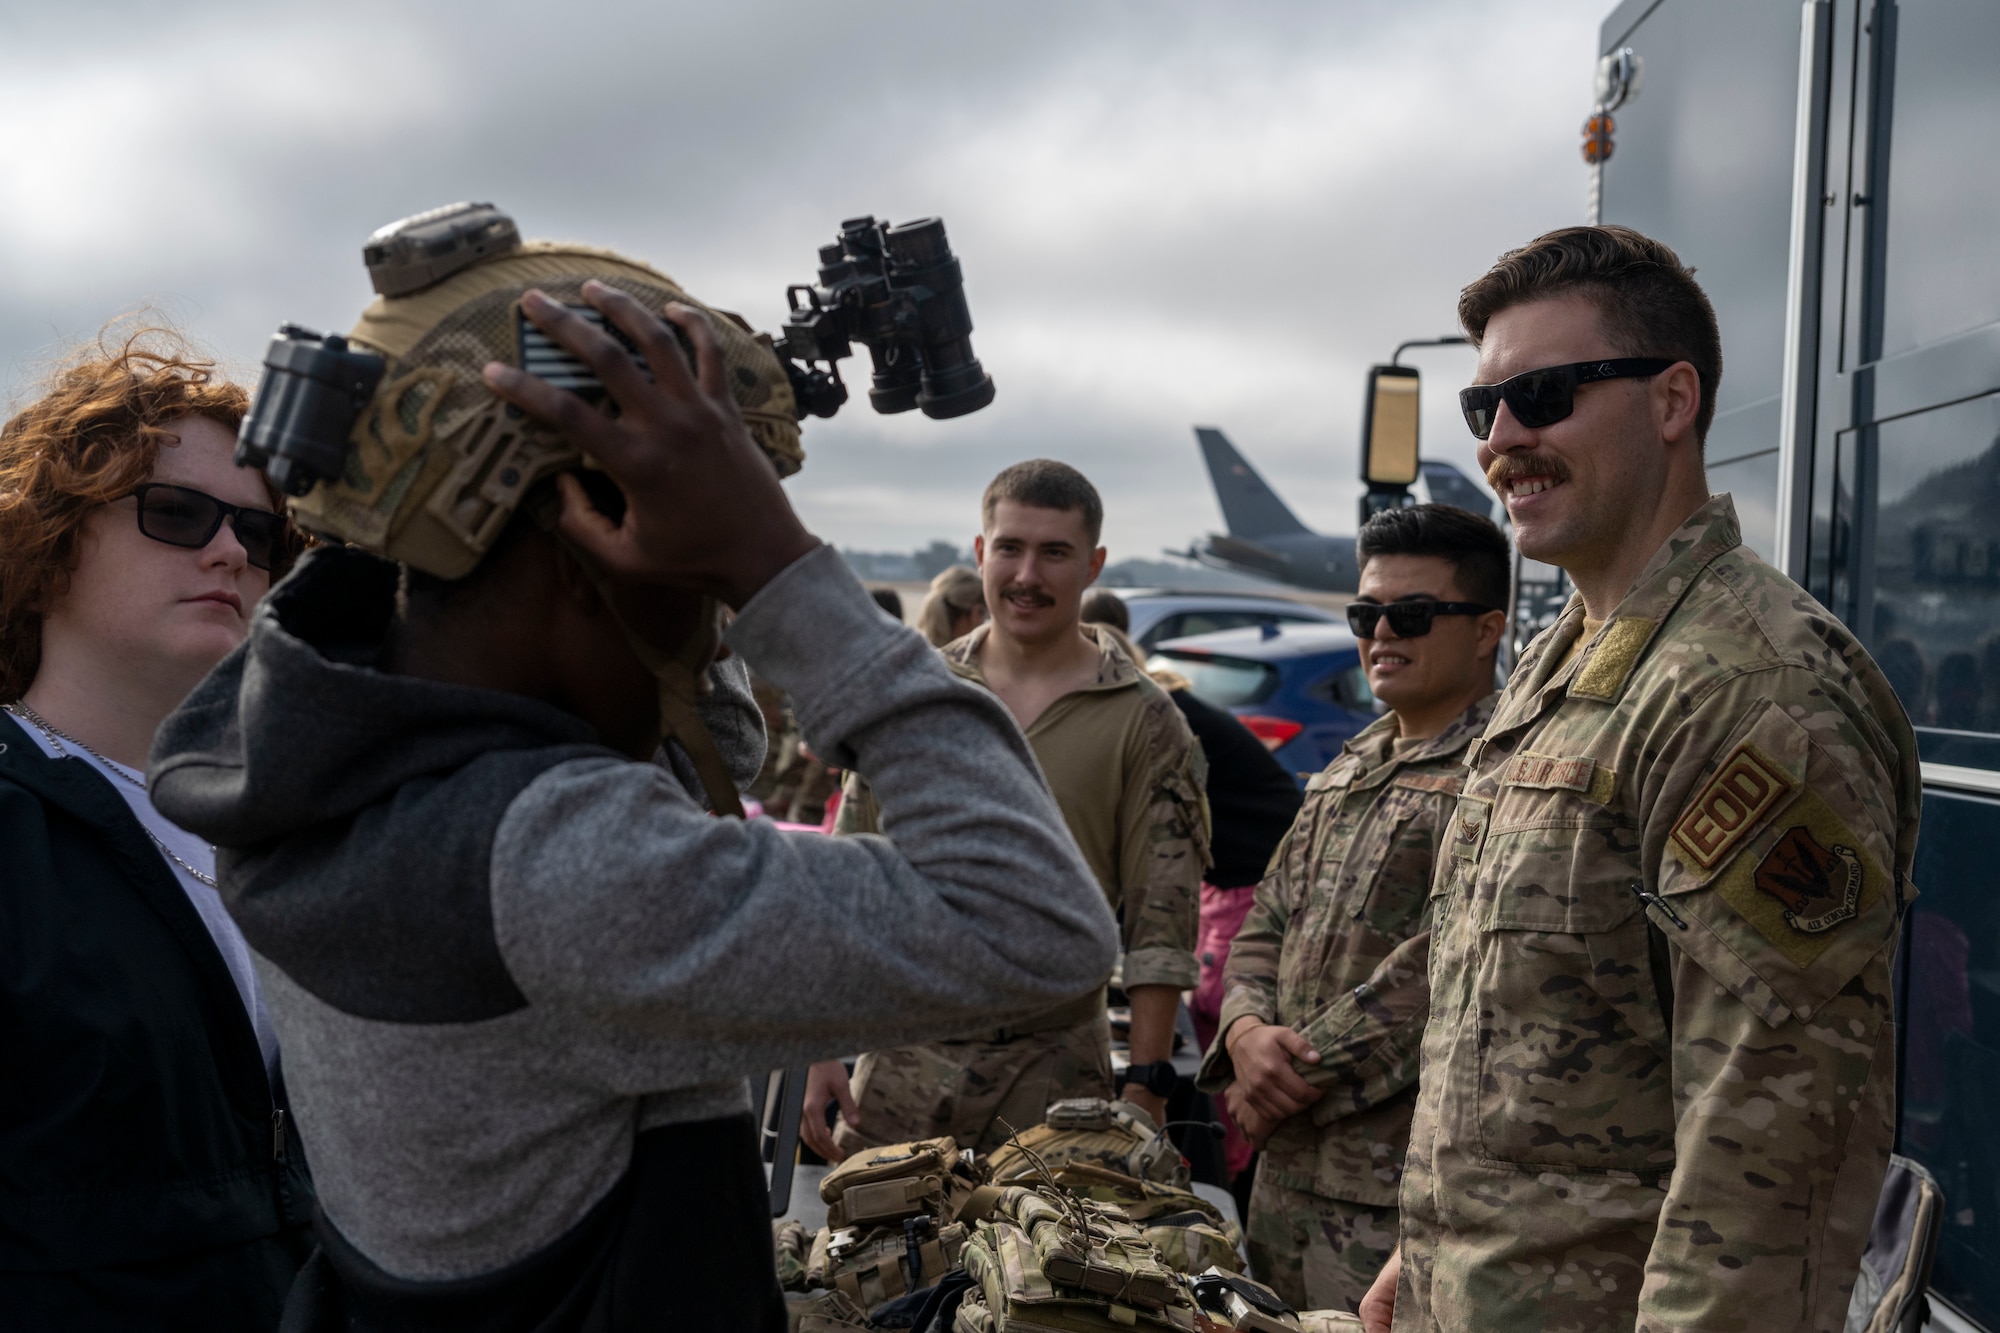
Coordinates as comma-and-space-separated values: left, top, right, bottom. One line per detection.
834, 1011, 1112, 1153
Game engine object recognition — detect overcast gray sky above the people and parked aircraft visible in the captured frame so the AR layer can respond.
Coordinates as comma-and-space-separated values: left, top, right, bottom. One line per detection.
0, 0, 1612, 558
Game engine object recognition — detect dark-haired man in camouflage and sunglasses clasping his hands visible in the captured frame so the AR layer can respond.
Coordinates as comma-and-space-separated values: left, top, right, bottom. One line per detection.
1200, 504, 1510, 1309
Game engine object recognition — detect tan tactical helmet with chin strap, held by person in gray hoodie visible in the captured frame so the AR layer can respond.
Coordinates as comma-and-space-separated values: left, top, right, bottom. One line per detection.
236, 204, 804, 815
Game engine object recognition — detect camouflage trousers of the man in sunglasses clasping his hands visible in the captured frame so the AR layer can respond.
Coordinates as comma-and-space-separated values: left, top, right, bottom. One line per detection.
1244, 1165, 1396, 1309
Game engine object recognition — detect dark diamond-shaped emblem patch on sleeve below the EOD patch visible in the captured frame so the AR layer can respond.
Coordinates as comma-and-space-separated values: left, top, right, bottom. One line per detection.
1716, 791, 1888, 969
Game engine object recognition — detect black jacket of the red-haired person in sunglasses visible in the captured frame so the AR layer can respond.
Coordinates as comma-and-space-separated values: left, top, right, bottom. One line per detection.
0, 715, 312, 1331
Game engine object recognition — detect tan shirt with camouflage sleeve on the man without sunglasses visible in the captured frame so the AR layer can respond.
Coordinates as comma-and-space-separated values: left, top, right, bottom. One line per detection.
834, 624, 1208, 991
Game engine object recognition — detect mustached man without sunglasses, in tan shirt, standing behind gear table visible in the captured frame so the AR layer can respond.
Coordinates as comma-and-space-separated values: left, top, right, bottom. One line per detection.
800, 458, 1208, 1157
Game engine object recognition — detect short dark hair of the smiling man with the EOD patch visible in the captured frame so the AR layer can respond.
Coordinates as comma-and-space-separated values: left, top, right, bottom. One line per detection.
1458, 226, 1722, 444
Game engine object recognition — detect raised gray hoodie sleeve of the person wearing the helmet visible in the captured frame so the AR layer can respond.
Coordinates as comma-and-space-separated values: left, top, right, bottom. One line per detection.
480, 546, 1118, 1087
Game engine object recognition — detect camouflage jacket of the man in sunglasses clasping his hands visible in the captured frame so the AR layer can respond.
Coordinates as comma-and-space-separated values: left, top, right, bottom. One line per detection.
1198, 695, 1494, 1207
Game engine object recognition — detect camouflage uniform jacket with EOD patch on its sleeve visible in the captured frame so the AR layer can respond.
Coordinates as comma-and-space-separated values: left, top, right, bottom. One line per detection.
1396, 496, 1918, 1333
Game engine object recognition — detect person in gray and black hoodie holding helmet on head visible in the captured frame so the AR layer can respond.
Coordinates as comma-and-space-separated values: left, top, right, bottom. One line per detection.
150, 220, 1118, 1333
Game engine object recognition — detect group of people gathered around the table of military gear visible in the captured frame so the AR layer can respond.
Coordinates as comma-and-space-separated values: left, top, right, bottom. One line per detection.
0, 226, 1918, 1333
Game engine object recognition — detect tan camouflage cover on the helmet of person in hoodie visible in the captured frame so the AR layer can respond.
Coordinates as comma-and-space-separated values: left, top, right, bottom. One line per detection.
292, 240, 804, 578
